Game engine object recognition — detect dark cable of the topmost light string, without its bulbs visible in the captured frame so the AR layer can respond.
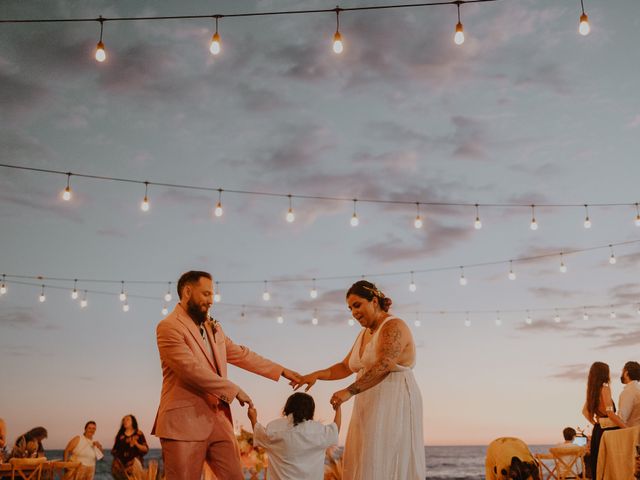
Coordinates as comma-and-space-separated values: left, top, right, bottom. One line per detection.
0, 0, 498, 23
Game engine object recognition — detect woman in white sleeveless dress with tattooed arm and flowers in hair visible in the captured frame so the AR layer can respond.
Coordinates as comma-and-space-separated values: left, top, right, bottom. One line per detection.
296, 280, 425, 480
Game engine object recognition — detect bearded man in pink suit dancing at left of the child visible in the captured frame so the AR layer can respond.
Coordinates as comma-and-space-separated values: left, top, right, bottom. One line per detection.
151, 271, 300, 480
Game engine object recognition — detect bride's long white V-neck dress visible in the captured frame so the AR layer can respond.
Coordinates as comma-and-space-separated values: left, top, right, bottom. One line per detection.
343, 317, 426, 480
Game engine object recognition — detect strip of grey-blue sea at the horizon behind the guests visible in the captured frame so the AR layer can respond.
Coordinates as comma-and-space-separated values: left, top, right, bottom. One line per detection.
46, 445, 551, 480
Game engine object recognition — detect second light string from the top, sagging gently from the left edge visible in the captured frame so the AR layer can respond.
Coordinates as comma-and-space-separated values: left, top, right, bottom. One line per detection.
0, 163, 640, 217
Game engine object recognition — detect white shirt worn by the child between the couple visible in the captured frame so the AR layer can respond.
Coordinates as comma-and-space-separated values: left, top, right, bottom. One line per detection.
253, 415, 338, 480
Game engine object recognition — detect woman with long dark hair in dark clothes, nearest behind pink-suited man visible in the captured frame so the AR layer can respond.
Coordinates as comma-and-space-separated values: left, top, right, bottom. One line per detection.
111, 415, 149, 480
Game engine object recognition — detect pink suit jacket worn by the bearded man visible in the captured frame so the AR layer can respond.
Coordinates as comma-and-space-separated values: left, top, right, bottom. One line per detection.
151, 304, 283, 441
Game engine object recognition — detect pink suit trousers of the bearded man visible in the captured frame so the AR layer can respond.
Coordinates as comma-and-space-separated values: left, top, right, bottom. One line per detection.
160, 405, 244, 480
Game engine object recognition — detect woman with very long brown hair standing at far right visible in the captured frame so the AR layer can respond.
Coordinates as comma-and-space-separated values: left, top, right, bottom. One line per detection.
582, 362, 626, 476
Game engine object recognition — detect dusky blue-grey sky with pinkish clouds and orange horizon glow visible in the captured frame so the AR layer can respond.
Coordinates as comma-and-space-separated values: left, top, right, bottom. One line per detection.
0, 0, 640, 448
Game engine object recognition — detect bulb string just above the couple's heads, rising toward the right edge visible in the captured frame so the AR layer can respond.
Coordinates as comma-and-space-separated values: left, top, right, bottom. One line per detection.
2, 240, 640, 288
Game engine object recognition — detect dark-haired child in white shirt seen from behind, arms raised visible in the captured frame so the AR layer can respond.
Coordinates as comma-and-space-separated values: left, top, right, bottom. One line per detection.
248, 392, 341, 480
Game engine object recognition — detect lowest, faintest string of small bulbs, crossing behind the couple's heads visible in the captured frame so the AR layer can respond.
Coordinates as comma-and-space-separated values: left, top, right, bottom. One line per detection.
3, 280, 640, 324
